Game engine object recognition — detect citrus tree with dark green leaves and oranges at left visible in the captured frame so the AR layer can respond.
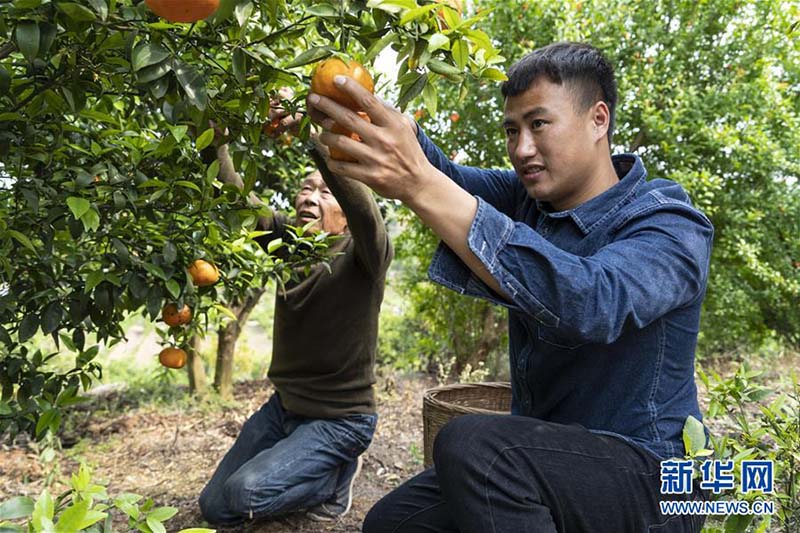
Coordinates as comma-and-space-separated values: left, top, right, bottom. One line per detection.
0, 0, 503, 436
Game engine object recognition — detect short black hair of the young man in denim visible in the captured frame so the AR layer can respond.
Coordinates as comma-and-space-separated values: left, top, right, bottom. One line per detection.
500, 42, 617, 145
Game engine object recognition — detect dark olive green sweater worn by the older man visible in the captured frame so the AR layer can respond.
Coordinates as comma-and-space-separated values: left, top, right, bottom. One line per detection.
259, 169, 393, 418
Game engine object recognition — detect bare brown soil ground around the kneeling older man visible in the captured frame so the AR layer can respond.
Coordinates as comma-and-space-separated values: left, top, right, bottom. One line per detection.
0, 377, 435, 533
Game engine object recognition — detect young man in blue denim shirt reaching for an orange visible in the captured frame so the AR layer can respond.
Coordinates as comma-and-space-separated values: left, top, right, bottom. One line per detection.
309, 43, 713, 533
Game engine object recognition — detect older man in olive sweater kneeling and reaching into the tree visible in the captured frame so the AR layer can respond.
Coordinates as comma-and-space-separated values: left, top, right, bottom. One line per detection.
200, 139, 392, 525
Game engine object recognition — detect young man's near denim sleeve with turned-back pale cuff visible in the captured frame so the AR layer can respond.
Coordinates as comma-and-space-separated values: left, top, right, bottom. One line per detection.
429, 198, 713, 344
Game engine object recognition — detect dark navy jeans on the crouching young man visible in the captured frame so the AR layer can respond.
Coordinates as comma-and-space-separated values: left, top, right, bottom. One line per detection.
363, 415, 706, 533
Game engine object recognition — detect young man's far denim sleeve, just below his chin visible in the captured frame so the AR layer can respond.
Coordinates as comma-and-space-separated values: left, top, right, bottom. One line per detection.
417, 127, 525, 216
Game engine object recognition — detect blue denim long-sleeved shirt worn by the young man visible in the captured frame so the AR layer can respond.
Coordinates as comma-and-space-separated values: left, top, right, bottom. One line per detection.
418, 129, 713, 458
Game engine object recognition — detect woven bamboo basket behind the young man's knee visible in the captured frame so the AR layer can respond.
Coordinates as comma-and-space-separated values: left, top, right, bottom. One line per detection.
422, 382, 511, 468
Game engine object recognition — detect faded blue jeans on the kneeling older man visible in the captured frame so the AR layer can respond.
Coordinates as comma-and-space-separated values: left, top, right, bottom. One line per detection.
200, 393, 378, 525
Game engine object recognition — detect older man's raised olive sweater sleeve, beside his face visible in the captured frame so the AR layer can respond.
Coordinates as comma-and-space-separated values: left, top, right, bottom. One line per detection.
311, 150, 394, 279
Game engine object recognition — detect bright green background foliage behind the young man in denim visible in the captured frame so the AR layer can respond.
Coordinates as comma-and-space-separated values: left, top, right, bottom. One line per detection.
388, 0, 800, 376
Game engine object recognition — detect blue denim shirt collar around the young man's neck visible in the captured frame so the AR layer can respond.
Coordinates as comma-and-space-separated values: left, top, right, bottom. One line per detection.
536, 154, 647, 235
